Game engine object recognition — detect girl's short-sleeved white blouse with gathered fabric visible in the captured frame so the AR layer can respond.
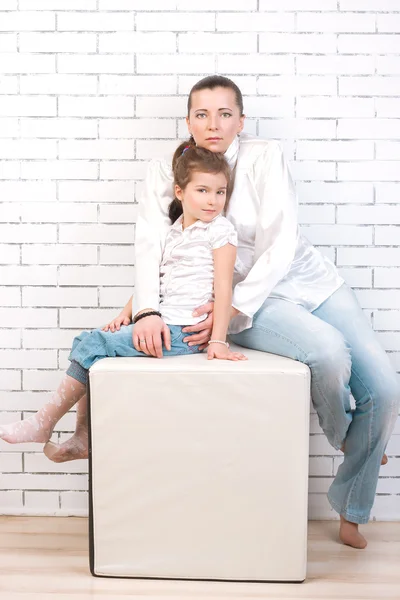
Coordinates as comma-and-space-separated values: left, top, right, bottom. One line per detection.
160, 215, 237, 325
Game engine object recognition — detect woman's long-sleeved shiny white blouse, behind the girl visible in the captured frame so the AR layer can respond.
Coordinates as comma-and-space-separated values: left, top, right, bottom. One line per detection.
132, 134, 344, 333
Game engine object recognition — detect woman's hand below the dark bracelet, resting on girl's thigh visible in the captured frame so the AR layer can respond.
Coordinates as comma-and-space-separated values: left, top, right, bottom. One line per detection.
132, 315, 171, 358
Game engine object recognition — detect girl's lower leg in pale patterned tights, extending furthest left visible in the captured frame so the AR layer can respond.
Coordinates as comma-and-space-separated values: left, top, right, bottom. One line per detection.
0, 375, 86, 444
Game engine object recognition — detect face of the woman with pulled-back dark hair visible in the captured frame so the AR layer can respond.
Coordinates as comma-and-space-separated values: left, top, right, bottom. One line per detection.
186, 87, 245, 152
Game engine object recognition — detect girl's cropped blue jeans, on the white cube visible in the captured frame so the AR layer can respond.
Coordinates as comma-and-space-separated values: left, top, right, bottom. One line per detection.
67, 325, 203, 385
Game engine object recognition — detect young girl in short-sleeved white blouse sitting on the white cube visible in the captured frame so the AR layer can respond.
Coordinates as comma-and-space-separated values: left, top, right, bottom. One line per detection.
0, 146, 246, 458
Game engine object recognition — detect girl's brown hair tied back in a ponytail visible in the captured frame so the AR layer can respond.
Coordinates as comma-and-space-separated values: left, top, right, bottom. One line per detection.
168, 142, 231, 223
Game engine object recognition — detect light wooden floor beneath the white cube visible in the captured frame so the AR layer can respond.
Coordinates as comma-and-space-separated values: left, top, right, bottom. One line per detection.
0, 517, 400, 600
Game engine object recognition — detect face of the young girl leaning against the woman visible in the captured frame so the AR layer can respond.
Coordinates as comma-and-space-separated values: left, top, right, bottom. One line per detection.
175, 171, 227, 229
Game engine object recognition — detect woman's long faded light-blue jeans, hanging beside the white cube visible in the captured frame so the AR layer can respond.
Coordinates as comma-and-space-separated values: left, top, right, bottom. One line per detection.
230, 284, 400, 523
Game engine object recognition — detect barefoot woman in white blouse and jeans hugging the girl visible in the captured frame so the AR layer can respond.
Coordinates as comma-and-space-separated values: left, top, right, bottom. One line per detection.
104, 75, 400, 548
